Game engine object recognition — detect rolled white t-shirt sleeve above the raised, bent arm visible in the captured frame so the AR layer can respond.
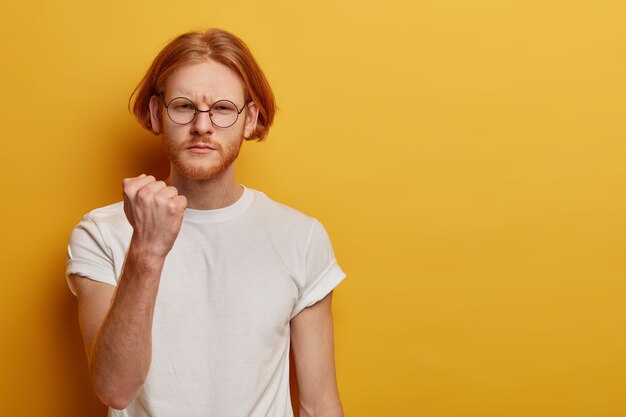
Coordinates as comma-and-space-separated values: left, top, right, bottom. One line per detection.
65, 215, 117, 294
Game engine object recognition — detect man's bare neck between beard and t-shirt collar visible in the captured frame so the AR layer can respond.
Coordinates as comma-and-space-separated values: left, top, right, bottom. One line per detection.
167, 165, 243, 210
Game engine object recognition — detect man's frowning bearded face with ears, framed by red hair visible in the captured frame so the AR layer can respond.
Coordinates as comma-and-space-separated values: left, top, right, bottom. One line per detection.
150, 60, 258, 180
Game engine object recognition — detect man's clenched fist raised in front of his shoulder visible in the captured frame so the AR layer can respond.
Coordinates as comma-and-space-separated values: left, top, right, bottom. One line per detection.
123, 175, 187, 257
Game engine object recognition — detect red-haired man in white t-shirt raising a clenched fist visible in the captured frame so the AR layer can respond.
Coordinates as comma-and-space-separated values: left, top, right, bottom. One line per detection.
67, 29, 344, 417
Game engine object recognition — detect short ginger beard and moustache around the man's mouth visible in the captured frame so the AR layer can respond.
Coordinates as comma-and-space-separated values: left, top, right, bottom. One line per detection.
163, 133, 243, 180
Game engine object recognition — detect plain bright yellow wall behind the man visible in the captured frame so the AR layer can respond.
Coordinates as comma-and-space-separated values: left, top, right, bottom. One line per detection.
0, 0, 626, 417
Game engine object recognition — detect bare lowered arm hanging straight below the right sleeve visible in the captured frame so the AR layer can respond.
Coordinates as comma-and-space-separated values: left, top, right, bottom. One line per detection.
291, 292, 343, 417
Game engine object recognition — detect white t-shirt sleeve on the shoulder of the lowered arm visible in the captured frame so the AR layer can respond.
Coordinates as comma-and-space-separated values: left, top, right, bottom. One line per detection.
291, 220, 346, 318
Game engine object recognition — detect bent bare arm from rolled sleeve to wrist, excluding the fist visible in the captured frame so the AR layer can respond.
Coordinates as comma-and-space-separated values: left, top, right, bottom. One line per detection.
70, 249, 165, 409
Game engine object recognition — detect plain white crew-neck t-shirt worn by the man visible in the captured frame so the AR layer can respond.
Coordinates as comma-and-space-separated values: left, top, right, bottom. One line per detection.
67, 188, 345, 417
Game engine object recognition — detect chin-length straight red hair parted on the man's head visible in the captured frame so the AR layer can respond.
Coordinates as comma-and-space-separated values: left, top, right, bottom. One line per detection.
129, 29, 276, 141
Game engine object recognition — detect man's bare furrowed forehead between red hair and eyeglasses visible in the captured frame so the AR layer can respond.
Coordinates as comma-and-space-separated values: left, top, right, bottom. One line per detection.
165, 59, 245, 102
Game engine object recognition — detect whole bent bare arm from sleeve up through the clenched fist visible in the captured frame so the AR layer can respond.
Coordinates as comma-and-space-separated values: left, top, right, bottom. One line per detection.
70, 176, 186, 409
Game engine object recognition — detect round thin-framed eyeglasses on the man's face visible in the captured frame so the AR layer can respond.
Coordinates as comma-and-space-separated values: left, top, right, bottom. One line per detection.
161, 96, 245, 128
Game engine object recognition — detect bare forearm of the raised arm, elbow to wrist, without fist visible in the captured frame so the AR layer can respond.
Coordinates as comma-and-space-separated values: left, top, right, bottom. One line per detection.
89, 244, 163, 409
